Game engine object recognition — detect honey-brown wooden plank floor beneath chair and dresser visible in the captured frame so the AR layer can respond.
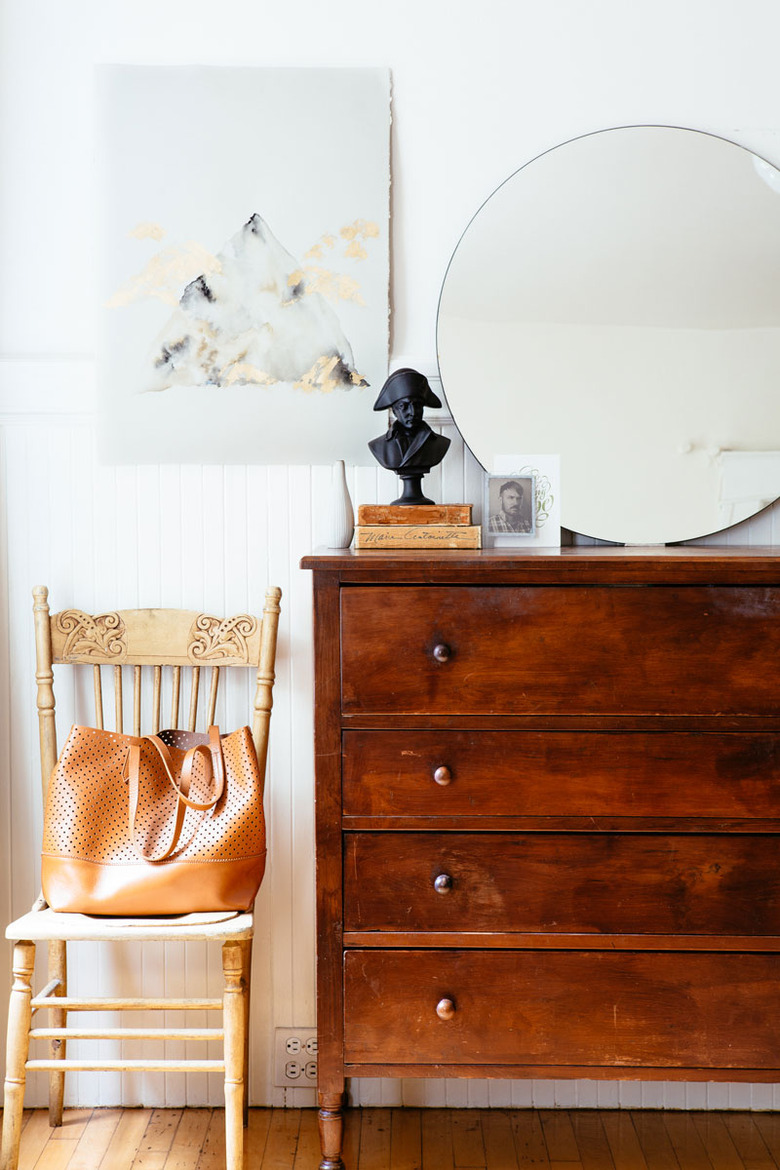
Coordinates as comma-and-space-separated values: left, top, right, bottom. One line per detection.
7, 1109, 780, 1170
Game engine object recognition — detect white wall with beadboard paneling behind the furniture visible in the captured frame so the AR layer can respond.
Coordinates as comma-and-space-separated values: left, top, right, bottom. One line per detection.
0, 0, 780, 1107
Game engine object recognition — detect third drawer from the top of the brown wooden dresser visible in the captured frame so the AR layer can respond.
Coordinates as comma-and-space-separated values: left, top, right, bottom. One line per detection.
344, 833, 780, 935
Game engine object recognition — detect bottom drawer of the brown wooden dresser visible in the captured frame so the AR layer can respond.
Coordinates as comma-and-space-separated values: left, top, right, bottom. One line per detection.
344, 950, 780, 1069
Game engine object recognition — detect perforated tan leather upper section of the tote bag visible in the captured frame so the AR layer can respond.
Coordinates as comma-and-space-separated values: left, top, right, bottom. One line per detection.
42, 727, 265, 865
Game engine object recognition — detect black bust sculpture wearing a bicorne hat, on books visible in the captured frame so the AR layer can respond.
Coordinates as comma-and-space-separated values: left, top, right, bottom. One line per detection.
368, 369, 450, 504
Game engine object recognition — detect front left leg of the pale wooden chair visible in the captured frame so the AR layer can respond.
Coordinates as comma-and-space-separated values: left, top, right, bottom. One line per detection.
0, 941, 35, 1170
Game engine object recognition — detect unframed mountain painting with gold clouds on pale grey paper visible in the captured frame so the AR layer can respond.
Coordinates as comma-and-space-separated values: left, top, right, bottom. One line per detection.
97, 66, 389, 463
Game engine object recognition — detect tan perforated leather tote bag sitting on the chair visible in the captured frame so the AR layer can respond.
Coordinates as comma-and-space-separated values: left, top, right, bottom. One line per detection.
41, 727, 265, 916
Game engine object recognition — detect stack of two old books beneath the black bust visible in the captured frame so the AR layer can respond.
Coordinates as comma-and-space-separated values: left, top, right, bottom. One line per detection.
354, 504, 482, 549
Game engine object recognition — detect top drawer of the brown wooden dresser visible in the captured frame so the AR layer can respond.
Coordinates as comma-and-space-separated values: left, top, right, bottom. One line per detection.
340, 585, 780, 716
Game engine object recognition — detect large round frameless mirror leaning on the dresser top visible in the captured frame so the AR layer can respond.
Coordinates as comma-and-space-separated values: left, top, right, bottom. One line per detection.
437, 126, 780, 544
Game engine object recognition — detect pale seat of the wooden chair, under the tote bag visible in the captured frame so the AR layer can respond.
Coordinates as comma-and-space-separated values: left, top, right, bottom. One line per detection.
6, 906, 253, 942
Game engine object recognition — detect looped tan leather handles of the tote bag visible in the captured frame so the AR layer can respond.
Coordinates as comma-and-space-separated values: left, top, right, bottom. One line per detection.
123, 727, 225, 861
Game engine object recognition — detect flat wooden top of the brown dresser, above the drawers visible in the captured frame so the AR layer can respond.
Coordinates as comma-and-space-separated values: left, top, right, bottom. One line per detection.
301, 545, 780, 585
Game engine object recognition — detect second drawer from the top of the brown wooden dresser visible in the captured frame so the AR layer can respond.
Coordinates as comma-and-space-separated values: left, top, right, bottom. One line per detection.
341, 730, 780, 819
